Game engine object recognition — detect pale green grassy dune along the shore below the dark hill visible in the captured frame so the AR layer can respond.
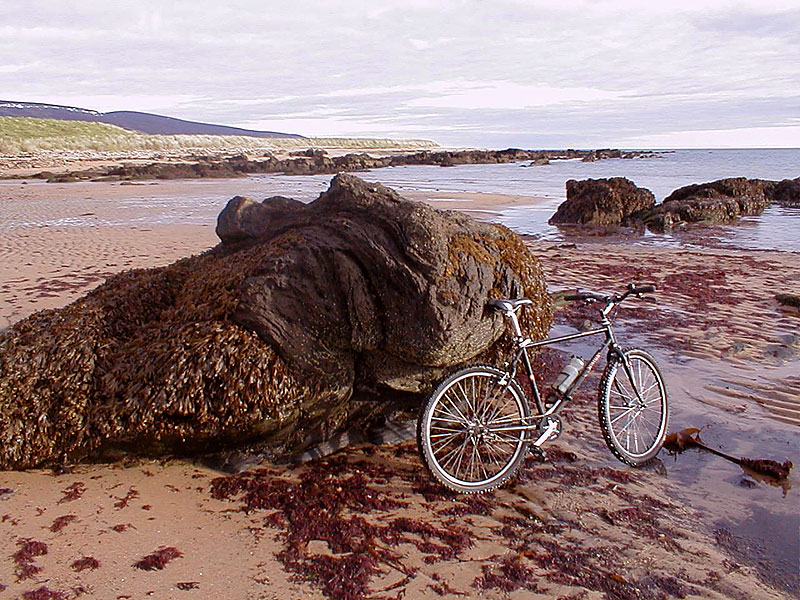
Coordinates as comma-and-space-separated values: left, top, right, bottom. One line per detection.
0, 117, 436, 155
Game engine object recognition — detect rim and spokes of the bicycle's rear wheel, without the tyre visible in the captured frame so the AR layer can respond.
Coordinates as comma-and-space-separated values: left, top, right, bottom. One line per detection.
426, 373, 525, 487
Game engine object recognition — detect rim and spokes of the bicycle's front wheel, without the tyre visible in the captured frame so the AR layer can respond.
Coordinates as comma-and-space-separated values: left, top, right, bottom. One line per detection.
606, 356, 666, 457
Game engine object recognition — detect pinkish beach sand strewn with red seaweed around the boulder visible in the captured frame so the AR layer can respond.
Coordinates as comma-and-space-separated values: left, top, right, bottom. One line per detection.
0, 180, 800, 599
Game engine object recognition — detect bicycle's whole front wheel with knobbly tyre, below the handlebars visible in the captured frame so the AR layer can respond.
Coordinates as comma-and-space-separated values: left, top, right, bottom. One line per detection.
598, 348, 669, 467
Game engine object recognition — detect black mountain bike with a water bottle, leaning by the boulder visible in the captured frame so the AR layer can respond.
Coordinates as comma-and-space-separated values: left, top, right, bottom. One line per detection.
417, 284, 669, 493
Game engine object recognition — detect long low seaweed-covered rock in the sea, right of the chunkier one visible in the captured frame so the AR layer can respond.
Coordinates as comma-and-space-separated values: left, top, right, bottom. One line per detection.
643, 177, 770, 231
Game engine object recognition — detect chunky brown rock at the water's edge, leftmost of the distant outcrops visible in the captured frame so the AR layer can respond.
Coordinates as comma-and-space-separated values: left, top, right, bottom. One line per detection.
549, 177, 655, 227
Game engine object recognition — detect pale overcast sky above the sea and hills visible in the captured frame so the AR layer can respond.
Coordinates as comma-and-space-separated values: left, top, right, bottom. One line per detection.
0, 0, 800, 148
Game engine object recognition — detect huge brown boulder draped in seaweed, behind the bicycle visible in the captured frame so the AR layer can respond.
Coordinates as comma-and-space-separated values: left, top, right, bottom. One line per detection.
0, 175, 551, 468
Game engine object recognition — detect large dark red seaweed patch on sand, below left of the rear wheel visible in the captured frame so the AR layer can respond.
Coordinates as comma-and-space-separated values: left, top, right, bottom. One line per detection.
211, 455, 482, 600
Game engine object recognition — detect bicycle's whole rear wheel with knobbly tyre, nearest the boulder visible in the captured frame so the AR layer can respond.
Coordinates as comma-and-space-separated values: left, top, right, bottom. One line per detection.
417, 366, 530, 493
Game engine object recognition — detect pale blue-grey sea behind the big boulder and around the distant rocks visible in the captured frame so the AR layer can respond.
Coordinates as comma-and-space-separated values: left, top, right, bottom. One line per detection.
248, 148, 800, 252
